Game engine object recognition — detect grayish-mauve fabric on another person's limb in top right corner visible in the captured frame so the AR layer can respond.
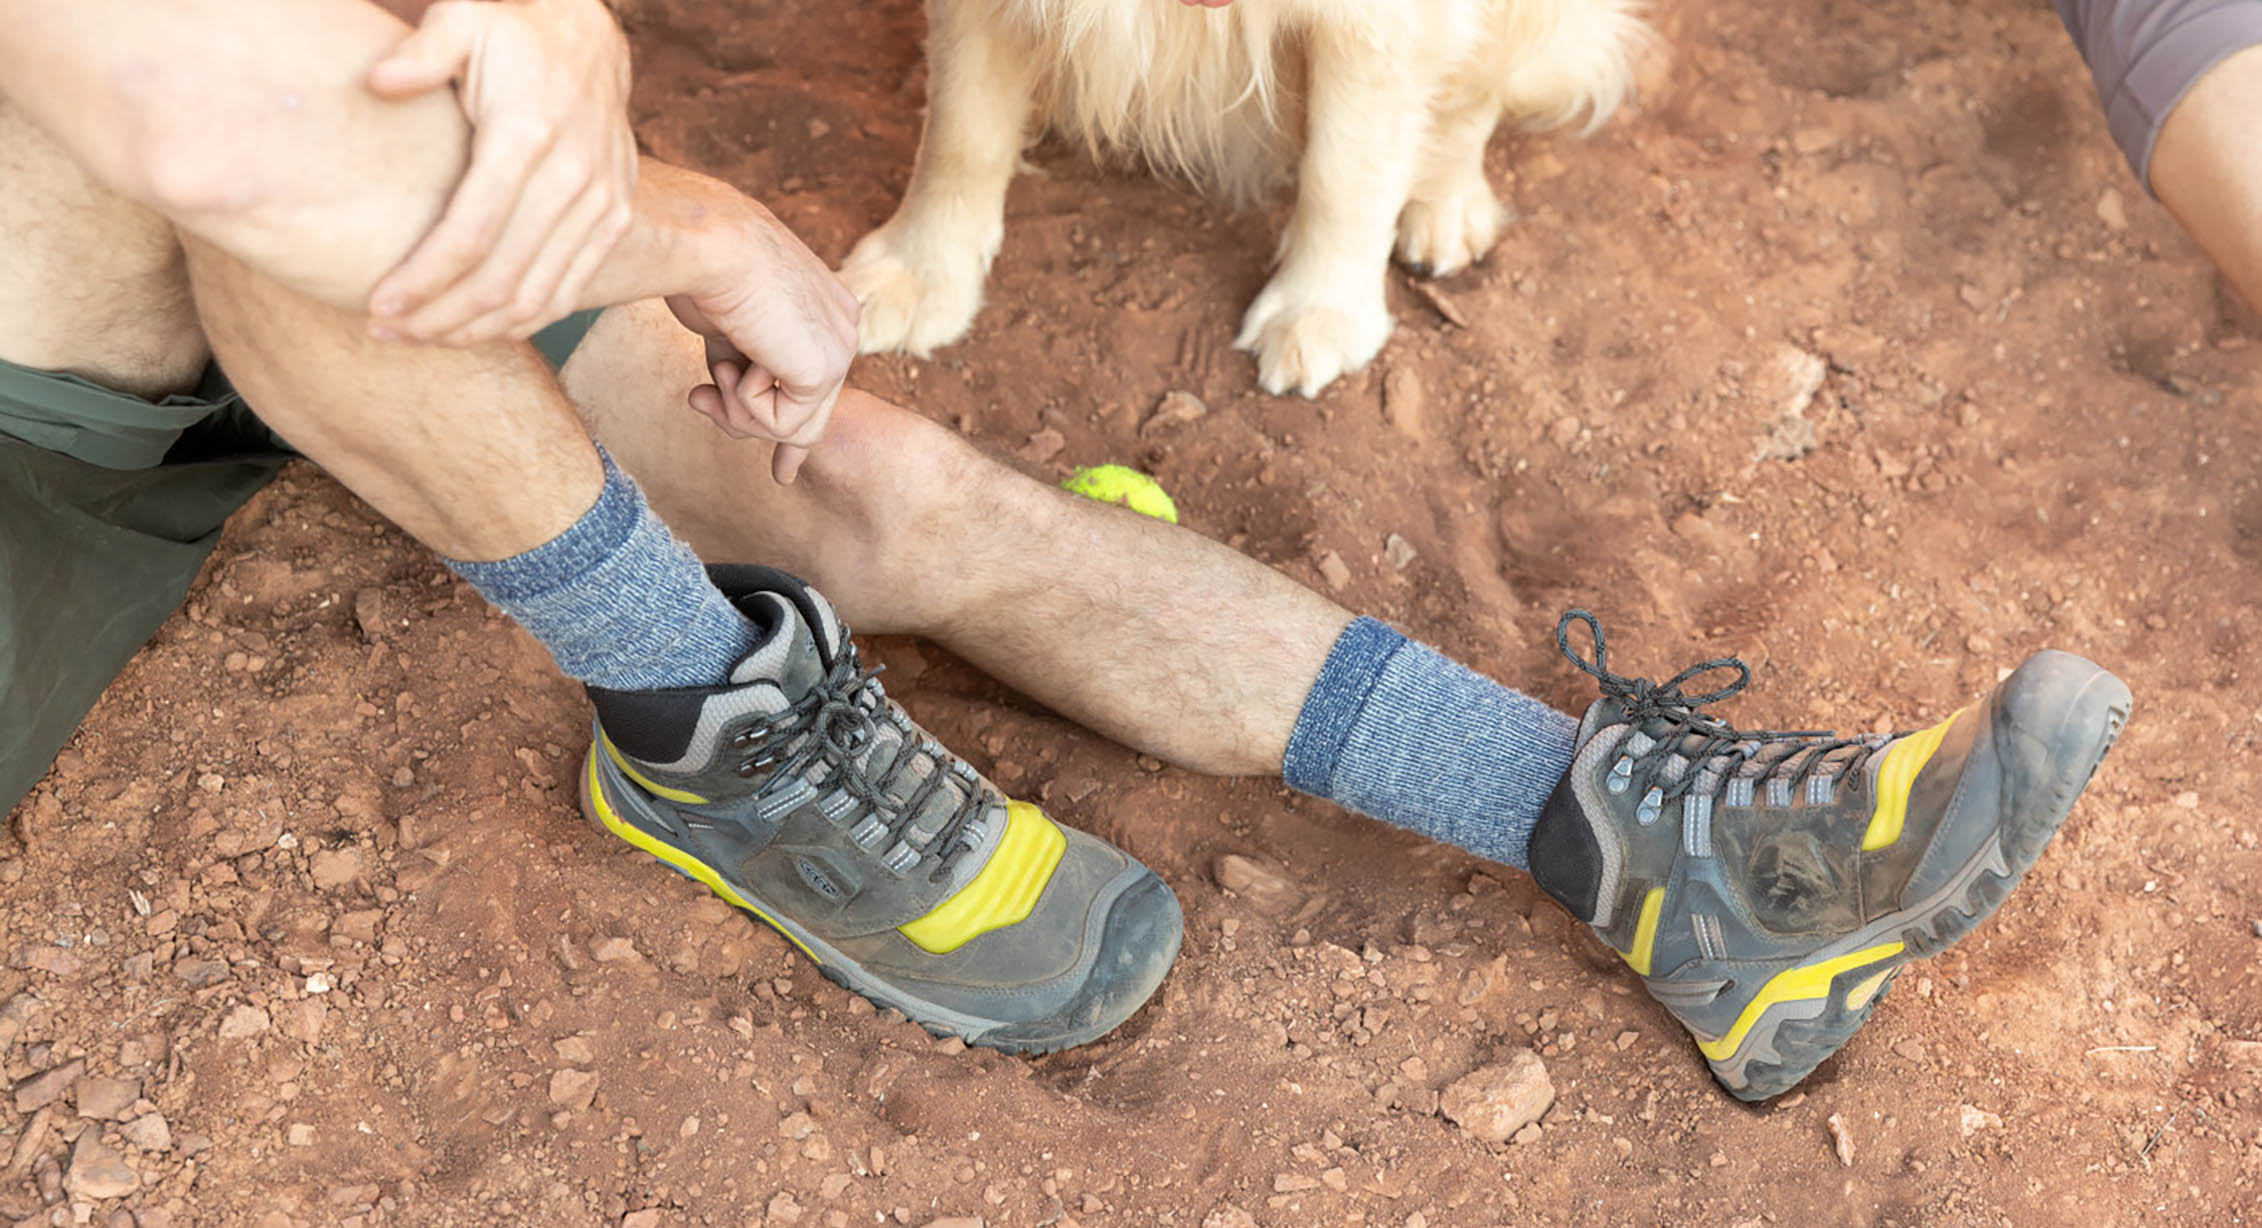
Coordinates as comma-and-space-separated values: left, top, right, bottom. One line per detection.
2056, 0, 2262, 192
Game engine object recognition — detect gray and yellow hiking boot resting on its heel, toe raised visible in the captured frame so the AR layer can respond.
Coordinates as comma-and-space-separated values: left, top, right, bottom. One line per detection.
1531, 611, 2129, 1099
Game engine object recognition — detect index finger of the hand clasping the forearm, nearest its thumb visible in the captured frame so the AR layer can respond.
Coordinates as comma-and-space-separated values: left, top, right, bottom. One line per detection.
369, 122, 554, 323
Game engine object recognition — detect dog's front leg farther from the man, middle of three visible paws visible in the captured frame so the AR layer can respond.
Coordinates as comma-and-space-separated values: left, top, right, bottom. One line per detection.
1233, 27, 1430, 396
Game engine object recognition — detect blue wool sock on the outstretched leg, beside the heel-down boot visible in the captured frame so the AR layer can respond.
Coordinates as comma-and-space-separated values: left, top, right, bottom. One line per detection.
1283, 617, 1579, 868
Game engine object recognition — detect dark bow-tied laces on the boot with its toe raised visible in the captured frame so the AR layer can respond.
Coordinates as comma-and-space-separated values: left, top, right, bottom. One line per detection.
1556, 611, 1893, 823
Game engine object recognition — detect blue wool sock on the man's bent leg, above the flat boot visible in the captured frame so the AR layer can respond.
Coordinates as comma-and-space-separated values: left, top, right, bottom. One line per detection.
448, 448, 760, 690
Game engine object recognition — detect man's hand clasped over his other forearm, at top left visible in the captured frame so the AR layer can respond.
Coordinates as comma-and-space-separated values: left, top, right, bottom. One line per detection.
369, 0, 638, 346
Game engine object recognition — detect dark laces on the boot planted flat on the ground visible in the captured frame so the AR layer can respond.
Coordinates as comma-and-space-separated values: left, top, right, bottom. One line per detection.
731, 645, 988, 882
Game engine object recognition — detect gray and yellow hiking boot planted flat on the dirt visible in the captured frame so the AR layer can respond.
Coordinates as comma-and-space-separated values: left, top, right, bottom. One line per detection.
581, 568, 1181, 1054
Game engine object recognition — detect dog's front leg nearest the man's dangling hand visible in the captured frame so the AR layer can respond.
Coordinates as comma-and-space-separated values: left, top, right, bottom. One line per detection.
841, 0, 1038, 357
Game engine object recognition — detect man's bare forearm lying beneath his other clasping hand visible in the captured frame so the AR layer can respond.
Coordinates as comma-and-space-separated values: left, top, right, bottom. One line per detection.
0, 0, 756, 310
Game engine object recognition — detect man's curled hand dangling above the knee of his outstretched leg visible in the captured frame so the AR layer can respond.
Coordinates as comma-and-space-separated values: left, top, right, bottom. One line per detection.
667, 201, 860, 482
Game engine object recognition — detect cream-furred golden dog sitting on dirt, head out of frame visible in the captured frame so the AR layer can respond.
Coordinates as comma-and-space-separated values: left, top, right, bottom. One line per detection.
841, 0, 1647, 396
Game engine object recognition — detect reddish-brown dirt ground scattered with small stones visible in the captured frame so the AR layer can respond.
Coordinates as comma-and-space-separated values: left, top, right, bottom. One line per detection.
0, 0, 2262, 1228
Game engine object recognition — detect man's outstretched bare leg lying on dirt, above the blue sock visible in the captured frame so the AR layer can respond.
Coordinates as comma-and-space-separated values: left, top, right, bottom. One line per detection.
566, 303, 1350, 776
